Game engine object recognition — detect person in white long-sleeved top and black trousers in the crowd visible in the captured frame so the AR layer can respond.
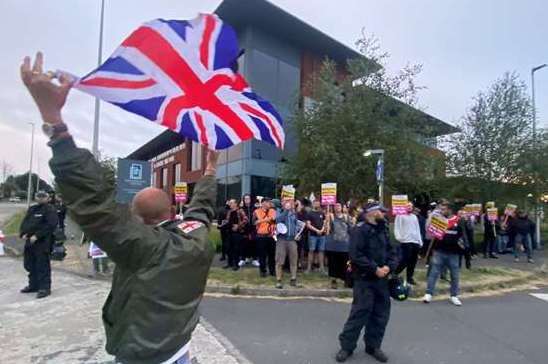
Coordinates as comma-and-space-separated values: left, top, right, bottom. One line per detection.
394, 203, 422, 284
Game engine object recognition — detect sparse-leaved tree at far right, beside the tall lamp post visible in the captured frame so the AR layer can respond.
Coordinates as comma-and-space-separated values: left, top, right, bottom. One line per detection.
447, 72, 535, 196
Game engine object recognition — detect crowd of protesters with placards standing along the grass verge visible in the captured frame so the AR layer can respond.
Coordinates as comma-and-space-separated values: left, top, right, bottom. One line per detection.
218, 195, 535, 298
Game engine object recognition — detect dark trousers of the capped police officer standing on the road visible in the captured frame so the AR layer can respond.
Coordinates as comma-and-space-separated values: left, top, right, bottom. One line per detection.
339, 279, 390, 352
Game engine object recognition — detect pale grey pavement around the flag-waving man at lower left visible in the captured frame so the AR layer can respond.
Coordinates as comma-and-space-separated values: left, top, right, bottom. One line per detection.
0, 257, 249, 364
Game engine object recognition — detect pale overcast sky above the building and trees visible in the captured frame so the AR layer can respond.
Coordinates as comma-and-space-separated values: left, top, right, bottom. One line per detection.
0, 0, 548, 180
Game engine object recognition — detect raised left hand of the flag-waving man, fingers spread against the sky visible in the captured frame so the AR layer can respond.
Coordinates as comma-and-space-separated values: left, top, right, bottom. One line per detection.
21, 52, 72, 124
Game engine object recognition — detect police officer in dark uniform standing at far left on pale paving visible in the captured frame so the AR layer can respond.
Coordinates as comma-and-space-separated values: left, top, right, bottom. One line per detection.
19, 191, 57, 298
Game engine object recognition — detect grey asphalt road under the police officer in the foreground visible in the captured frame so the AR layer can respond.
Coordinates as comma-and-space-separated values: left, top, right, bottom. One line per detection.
202, 290, 548, 364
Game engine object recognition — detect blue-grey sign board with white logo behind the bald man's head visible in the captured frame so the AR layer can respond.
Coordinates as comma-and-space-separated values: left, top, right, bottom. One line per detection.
116, 159, 151, 203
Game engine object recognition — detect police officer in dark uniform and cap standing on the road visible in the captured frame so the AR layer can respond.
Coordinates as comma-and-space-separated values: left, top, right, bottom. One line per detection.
336, 202, 398, 363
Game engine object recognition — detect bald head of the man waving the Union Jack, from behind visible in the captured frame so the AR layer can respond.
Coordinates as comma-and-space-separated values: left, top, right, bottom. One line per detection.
133, 187, 171, 225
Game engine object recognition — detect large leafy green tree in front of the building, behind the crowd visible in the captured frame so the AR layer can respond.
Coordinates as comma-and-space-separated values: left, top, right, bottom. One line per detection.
282, 31, 441, 199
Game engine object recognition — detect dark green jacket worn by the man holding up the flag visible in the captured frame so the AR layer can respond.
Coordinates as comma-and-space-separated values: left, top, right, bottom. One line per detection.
50, 139, 217, 364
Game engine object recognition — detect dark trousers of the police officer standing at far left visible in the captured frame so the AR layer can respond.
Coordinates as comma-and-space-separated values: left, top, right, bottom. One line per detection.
23, 242, 51, 290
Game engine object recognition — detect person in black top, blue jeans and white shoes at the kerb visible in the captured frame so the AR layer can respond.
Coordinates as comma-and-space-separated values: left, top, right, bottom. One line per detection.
423, 203, 466, 306
